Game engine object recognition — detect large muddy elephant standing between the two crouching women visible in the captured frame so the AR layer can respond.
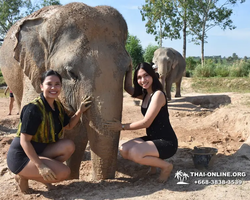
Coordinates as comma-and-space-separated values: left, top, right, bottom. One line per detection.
0, 3, 131, 180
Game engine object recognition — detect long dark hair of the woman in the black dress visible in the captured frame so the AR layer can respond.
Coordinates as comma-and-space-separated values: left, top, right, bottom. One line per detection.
132, 62, 163, 97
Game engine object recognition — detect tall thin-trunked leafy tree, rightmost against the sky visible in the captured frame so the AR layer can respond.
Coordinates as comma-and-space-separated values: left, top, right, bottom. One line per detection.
187, 0, 245, 64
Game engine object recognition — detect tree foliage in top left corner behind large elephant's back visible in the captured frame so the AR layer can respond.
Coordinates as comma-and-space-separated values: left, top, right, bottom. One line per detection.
0, 0, 60, 41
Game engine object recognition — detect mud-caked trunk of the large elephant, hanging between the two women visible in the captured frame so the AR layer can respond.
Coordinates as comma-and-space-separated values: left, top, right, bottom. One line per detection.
87, 90, 123, 180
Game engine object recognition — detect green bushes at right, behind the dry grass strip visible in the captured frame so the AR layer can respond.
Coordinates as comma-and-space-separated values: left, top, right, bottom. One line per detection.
186, 57, 250, 77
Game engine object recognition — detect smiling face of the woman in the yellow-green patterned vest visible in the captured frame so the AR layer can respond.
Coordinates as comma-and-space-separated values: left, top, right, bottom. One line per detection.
40, 75, 62, 99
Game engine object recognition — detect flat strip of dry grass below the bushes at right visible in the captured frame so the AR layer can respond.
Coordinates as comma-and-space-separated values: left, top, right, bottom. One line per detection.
192, 77, 250, 93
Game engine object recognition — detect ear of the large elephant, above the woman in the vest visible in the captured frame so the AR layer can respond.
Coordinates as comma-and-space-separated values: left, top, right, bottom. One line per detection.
14, 18, 47, 93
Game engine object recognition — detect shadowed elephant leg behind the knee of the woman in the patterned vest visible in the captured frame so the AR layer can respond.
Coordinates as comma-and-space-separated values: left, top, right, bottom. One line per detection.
64, 123, 88, 179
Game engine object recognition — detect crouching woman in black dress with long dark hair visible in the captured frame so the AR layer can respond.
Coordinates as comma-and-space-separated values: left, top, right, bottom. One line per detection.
106, 63, 178, 182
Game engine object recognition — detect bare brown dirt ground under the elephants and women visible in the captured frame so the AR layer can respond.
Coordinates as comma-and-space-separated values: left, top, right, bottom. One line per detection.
0, 78, 250, 200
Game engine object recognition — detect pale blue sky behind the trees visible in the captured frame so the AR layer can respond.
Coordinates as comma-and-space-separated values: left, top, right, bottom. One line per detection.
60, 0, 250, 57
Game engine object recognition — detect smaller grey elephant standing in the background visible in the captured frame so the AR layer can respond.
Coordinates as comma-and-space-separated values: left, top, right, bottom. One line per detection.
152, 47, 186, 101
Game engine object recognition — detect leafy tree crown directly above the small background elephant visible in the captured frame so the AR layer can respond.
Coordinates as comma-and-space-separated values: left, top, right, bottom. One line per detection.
140, 0, 181, 47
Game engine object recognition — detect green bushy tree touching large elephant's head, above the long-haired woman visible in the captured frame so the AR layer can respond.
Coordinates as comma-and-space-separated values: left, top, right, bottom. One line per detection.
125, 35, 144, 69
